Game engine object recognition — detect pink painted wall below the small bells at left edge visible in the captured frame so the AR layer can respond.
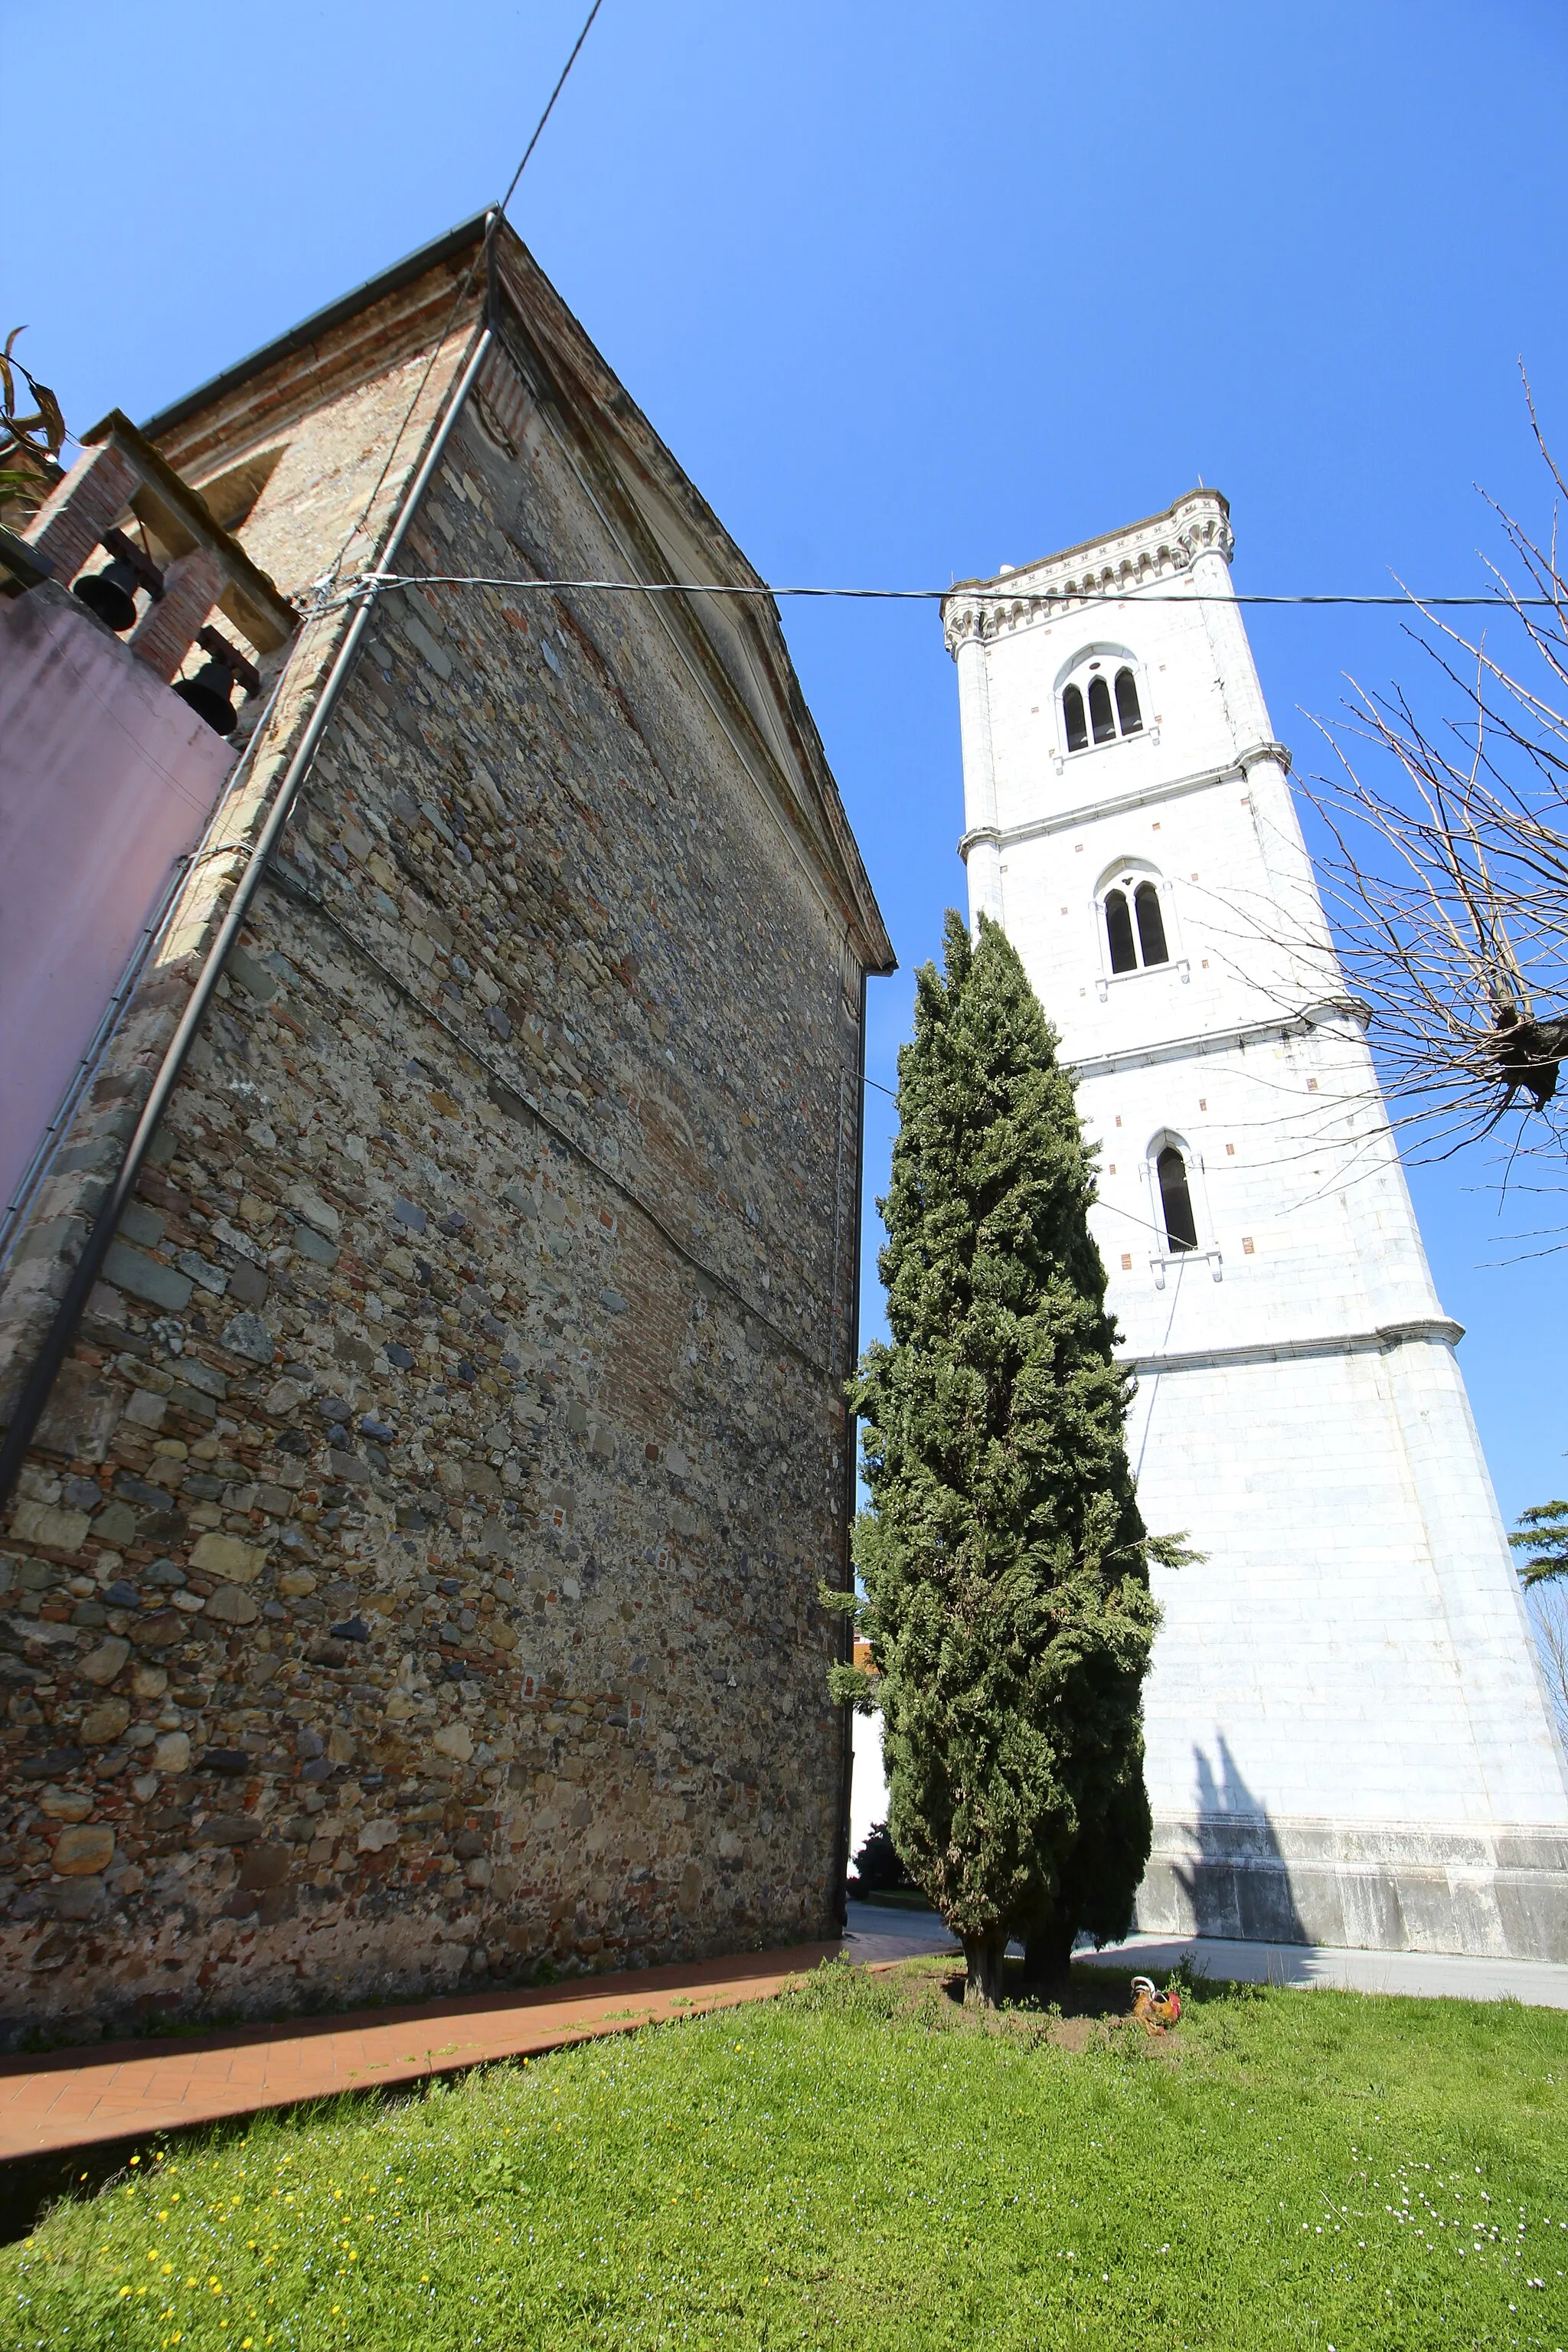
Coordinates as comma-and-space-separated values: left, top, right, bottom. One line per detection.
0, 586, 233, 1207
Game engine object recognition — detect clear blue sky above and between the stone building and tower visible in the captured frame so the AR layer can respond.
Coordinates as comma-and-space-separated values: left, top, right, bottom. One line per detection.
12, 0, 1568, 1514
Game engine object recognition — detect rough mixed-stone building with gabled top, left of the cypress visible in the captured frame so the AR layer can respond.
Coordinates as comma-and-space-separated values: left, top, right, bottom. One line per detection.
0, 233, 891, 2037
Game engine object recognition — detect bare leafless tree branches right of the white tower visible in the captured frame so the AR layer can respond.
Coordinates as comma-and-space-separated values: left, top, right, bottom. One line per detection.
1298, 384, 1568, 1214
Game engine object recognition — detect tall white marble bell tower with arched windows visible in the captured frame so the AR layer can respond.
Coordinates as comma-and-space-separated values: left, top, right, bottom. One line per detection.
942, 489, 1568, 1959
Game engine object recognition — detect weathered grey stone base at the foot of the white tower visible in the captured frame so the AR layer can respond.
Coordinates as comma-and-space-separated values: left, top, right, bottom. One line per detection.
1138, 1814, 1568, 1962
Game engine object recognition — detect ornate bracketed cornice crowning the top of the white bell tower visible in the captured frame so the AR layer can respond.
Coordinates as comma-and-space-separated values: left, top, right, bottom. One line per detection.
942, 489, 1236, 661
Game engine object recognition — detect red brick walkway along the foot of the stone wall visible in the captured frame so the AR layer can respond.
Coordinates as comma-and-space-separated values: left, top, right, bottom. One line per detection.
0, 1936, 893, 2161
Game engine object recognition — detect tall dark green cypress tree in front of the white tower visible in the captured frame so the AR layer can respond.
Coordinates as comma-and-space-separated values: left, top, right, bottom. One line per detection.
835, 913, 1175, 2004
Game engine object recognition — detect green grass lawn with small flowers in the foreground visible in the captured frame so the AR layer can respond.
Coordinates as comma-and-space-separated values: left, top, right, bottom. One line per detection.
0, 1964, 1568, 2352
